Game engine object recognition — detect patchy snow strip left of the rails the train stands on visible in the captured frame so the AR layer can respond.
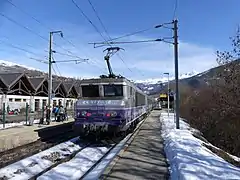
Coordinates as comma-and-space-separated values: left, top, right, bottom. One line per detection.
0, 138, 83, 180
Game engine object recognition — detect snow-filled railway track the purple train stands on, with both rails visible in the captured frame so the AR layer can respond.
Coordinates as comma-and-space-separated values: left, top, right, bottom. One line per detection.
34, 113, 148, 180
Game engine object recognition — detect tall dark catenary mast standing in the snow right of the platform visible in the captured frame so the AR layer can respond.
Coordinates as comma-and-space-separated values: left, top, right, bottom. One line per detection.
173, 20, 179, 129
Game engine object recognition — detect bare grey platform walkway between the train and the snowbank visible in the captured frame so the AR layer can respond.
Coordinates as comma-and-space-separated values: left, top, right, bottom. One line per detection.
101, 110, 169, 180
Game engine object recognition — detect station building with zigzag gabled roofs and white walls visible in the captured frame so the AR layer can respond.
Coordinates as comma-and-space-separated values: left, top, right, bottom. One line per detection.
0, 73, 81, 111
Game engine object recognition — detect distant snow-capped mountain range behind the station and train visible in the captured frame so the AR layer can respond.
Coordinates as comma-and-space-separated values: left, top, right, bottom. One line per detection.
0, 60, 232, 95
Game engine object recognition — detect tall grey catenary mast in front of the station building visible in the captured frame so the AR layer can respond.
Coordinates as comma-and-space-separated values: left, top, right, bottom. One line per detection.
48, 32, 52, 120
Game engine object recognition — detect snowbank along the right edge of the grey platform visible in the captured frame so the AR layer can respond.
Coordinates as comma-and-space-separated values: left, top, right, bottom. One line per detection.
160, 113, 240, 180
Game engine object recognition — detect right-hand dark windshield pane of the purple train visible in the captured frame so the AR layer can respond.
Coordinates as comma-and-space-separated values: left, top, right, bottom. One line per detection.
103, 84, 123, 97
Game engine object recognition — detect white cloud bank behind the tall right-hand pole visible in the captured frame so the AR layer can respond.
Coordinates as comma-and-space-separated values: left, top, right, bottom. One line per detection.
112, 39, 217, 77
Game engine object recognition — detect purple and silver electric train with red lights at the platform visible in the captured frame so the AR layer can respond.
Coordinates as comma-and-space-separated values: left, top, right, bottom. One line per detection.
73, 77, 155, 137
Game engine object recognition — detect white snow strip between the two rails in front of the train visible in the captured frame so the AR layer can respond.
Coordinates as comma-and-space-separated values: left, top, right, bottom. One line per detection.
37, 147, 110, 180
